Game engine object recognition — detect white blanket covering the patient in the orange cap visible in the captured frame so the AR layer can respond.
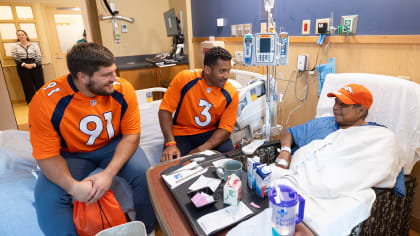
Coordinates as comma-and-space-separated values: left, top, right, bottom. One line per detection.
272, 126, 403, 236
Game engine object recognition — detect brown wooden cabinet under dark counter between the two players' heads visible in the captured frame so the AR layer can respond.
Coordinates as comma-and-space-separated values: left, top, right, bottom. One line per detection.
117, 65, 188, 90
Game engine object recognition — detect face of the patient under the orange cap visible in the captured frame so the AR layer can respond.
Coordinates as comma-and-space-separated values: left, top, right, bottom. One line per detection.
333, 98, 361, 128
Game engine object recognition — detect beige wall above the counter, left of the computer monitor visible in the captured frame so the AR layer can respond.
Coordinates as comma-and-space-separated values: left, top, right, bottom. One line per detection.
96, 0, 172, 56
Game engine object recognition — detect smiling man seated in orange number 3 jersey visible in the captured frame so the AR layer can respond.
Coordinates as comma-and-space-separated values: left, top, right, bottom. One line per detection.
159, 47, 239, 162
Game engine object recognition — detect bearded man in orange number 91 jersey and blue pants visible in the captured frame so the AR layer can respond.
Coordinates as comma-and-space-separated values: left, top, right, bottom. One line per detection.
29, 43, 155, 235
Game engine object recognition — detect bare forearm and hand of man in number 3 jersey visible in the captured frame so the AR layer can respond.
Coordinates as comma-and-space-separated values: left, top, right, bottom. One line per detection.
158, 110, 181, 162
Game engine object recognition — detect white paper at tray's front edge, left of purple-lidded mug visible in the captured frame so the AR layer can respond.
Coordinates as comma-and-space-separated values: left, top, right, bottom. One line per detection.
197, 202, 252, 235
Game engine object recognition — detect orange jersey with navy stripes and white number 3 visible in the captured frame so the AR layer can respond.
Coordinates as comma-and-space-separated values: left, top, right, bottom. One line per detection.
160, 70, 239, 136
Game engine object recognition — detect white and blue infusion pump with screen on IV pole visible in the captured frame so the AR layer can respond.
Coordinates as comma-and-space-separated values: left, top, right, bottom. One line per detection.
243, 32, 289, 66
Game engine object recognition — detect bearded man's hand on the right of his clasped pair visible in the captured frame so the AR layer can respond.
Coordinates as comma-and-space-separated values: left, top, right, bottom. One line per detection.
85, 170, 114, 205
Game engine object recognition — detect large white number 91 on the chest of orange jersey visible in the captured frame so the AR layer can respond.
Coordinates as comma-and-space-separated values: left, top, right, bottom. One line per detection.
79, 111, 115, 145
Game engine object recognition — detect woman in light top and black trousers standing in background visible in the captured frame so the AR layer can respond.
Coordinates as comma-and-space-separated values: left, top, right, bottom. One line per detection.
12, 30, 44, 104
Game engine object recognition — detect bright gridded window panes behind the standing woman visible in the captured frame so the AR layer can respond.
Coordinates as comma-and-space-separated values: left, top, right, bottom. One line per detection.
0, 3, 39, 59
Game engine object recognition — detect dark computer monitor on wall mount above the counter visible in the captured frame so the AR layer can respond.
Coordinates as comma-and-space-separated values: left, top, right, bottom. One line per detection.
163, 8, 184, 60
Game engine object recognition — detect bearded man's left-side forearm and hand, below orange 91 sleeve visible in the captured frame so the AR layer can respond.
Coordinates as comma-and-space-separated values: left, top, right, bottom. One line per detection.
37, 155, 92, 202
